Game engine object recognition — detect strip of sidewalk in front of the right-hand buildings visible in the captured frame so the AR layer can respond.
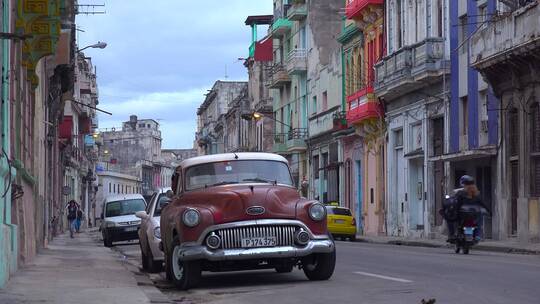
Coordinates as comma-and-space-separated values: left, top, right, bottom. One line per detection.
356, 235, 540, 255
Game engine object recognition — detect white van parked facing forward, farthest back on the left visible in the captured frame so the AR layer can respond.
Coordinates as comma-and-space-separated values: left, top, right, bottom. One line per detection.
101, 194, 146, 247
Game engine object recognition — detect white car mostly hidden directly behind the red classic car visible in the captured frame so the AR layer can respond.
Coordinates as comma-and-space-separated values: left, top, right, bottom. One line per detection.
136, 188, 172, 272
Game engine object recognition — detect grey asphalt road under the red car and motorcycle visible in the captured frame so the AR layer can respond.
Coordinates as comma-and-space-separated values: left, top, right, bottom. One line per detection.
116, 242, 540, 304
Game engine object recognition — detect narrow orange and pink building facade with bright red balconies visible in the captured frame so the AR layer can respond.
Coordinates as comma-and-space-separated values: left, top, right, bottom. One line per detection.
340, 0, 386, 235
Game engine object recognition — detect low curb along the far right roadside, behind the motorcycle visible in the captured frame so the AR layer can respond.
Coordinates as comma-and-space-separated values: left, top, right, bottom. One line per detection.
356, 237, 540, 255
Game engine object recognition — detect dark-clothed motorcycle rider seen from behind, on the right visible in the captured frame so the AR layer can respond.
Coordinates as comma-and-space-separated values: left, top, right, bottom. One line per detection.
447, 175, 491, 241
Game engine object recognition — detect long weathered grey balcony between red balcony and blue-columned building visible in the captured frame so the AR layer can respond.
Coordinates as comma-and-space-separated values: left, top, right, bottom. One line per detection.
375, 38, 450, 99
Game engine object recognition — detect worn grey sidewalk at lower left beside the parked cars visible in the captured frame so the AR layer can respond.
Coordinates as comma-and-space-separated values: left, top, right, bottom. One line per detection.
0, 232, 170, 304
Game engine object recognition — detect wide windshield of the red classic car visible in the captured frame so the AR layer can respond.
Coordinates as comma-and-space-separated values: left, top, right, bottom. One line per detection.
185, 160, 293, 191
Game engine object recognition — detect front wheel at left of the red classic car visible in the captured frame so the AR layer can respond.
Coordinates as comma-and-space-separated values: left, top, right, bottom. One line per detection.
166, 236, 201, 290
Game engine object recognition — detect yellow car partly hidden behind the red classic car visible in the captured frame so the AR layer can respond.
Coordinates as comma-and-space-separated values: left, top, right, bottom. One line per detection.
326, 206, 356, 242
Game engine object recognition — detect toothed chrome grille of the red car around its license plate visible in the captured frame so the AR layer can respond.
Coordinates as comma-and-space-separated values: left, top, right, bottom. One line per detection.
214, 225, 298, 249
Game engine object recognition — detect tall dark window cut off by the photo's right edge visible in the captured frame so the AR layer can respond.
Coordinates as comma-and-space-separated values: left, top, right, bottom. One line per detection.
529, 102, 540, 197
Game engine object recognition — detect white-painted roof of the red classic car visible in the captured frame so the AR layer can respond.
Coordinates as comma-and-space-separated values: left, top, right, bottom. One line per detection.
180, 152, 288, 168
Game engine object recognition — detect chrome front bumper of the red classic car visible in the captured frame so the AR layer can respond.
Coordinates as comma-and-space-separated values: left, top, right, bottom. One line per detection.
176, 239, 335, 261
